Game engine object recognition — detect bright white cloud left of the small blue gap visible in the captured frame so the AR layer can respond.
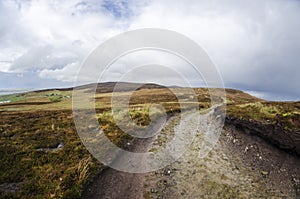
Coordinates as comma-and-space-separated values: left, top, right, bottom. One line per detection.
0, 0, 131, 72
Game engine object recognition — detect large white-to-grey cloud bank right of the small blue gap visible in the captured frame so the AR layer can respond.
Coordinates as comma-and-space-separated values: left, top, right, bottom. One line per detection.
131, 0, 300, 97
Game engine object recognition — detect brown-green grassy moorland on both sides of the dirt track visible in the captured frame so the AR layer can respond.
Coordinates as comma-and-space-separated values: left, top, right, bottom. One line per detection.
0, 88, 300, 198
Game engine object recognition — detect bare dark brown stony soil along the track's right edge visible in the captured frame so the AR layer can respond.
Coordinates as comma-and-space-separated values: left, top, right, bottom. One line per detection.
222, 125, 300, 198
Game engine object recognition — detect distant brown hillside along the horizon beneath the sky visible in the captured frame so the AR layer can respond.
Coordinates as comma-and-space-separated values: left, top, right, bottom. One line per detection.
0, 82, 264, 111
